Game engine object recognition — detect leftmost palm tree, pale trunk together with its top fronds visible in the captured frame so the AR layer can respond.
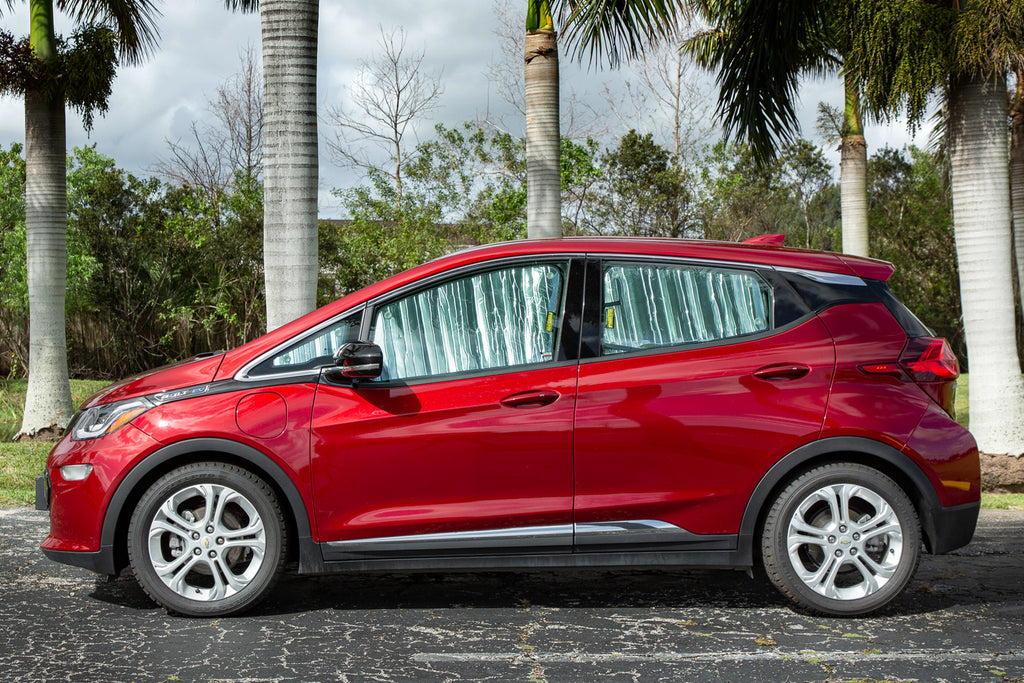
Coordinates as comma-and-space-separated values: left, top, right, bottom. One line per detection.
0, 0, 158, 436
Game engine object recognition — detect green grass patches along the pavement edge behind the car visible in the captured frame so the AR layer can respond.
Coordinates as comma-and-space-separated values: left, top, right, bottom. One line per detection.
0, 375, 1024, 510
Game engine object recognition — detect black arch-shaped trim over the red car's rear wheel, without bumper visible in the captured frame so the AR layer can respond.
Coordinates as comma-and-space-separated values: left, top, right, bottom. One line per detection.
739, 436, 941, 564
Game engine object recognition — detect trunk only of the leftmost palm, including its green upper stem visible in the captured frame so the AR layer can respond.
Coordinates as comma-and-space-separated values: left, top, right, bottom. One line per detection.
20, 0, 74, 436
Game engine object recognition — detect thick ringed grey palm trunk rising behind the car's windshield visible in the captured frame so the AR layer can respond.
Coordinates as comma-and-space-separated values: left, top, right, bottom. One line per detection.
260, 0, 319, 331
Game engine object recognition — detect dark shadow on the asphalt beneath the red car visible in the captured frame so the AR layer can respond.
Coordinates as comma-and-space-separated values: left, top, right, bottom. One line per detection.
91, 557, 1024, 618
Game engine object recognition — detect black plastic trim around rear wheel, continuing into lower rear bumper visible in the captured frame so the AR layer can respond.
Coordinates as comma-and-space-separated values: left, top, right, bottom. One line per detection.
738, 436, 977, 564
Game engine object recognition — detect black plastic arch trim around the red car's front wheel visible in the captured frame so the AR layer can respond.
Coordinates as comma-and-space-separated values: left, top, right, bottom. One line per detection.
100, 437, 324, 574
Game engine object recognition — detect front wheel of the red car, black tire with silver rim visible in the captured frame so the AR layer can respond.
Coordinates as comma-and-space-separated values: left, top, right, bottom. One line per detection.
128, 462, 287, 616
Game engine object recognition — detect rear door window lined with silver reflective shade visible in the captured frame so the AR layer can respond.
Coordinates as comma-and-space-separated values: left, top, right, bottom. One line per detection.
601, 262, 772, 355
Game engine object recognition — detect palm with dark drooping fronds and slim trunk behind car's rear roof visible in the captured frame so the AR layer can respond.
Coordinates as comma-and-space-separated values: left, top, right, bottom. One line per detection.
684, 0, 868, 256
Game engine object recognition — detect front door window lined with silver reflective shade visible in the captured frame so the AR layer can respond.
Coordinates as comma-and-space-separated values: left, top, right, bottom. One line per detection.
370, 262, 566, 381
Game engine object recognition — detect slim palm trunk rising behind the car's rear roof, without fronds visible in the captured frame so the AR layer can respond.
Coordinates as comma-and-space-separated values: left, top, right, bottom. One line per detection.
840, 75, 869, 256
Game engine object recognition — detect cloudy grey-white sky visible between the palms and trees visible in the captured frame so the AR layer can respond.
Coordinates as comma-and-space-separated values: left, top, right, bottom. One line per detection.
0, 0, 927, 218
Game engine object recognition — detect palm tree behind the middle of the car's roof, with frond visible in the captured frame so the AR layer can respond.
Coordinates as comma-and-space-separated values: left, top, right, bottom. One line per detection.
523, 0, 687, 238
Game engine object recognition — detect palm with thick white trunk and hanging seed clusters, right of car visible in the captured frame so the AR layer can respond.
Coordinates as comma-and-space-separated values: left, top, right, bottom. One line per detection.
843, 0, 1024, 456
